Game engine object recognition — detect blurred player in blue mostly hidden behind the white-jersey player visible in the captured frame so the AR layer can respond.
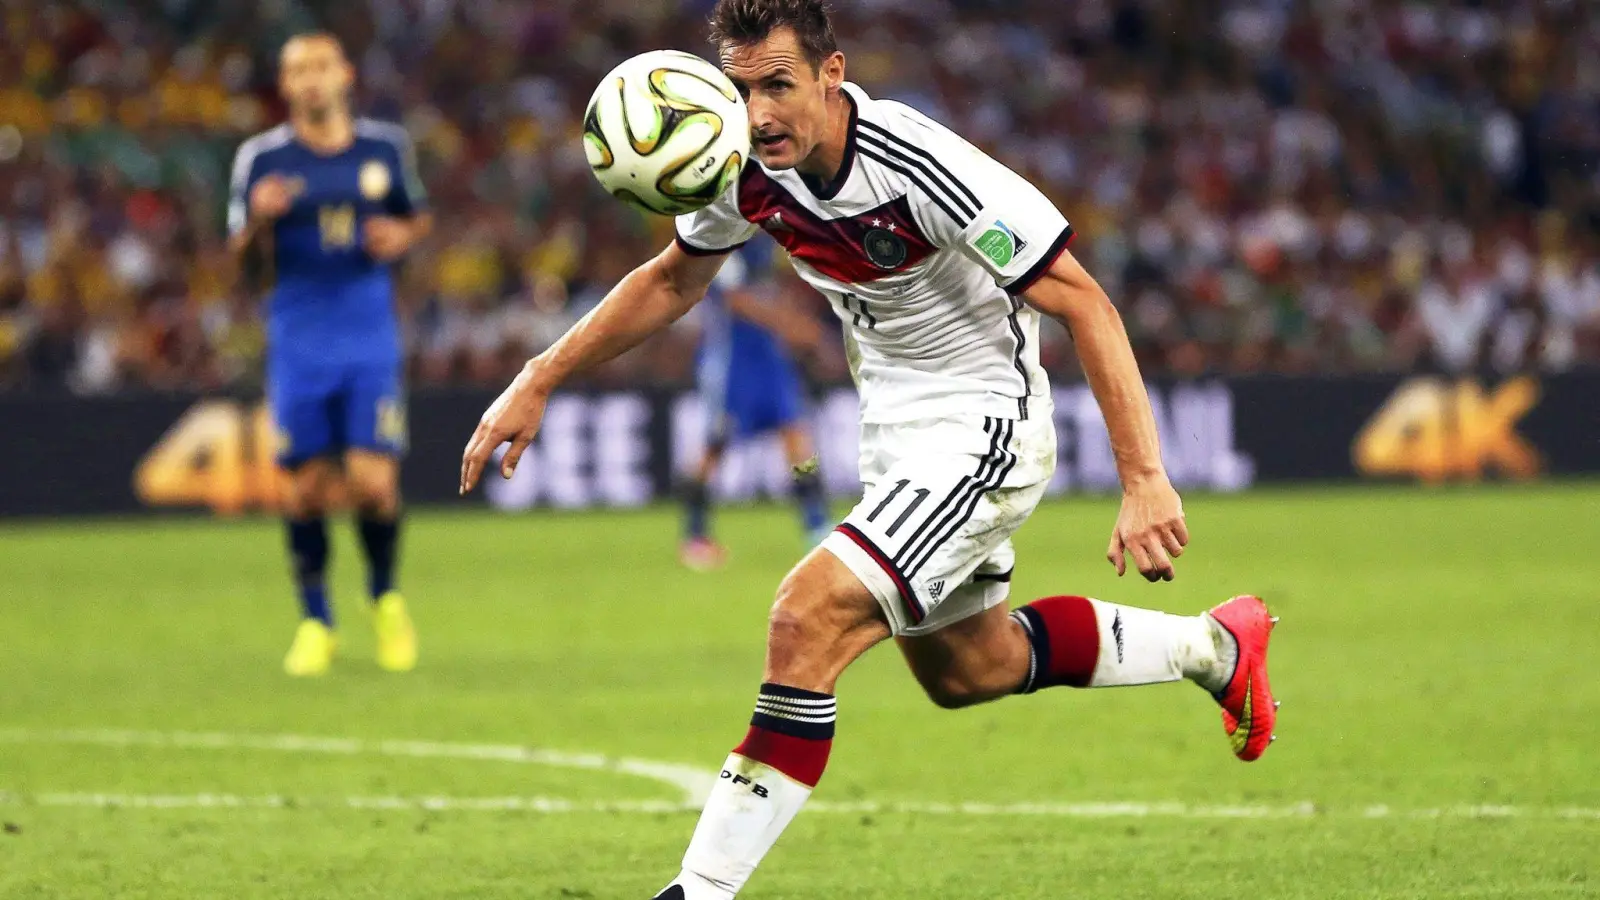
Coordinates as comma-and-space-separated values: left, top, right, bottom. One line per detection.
680, 240, 832, 572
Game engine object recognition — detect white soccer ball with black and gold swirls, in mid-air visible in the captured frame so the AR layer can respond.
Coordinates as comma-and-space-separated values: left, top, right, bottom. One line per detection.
584, 50, 750, 216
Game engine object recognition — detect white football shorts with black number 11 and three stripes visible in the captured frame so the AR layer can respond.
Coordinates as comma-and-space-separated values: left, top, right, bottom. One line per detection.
822, 408, 1056, 636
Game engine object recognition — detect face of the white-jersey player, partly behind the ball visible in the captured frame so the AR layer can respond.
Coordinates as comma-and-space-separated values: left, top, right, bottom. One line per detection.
722, 27, 845, 170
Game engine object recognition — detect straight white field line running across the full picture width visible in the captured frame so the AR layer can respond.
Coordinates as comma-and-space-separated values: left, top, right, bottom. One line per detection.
0, 791, 1600, 822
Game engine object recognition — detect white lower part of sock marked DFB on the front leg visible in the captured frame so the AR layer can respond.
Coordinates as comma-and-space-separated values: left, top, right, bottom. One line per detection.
669, 753, 811, 900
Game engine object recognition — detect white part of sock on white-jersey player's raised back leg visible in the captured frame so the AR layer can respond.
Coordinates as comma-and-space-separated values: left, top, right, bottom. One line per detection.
1090, 599, 1237, 693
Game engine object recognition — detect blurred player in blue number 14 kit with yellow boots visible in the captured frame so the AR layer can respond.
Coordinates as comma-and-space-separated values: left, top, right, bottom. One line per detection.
227, 34, 432, 676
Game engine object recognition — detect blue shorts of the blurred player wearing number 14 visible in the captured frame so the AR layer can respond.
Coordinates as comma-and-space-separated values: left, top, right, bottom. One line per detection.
267, 362, 406, 468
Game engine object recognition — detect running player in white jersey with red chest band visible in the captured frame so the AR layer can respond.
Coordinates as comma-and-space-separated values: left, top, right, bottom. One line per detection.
461, 0, 1277, 900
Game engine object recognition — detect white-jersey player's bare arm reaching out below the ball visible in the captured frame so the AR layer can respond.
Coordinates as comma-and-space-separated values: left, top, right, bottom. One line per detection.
461, 243, 726, 493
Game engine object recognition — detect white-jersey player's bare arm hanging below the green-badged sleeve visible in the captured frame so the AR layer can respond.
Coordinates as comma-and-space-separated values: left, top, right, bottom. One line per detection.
1024, 253, 1189, 581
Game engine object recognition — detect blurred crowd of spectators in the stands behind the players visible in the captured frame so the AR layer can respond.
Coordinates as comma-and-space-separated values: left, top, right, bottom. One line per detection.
0, 0, 1600, 392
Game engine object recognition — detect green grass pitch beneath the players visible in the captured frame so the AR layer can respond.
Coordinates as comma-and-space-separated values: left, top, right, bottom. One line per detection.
0, 484, 1600, 900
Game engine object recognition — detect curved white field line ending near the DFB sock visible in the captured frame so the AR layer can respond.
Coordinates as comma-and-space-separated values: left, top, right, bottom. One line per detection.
0, 729, 717, 806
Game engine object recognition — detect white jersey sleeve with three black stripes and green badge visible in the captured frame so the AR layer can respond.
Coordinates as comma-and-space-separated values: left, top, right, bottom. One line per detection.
889, 114, 1074, 295
